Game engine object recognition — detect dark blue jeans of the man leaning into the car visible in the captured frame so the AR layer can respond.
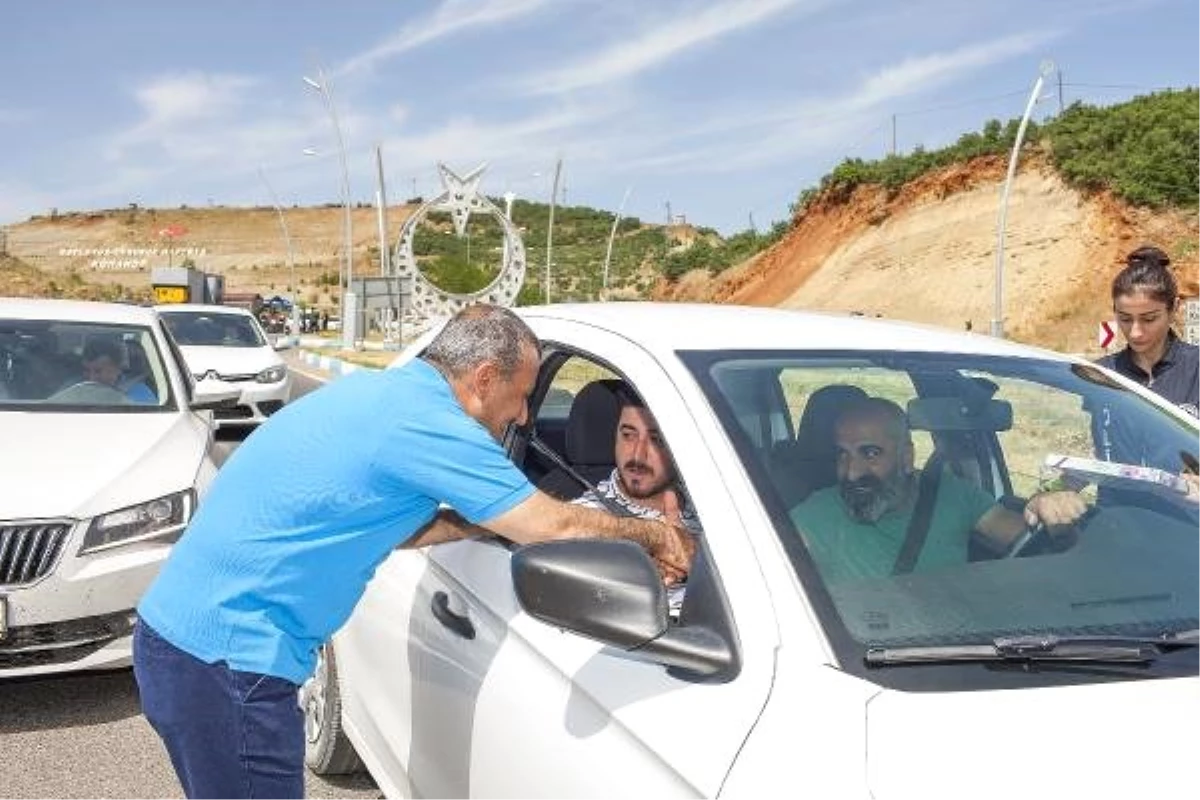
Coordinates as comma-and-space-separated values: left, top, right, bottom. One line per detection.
133, 620, 304, 800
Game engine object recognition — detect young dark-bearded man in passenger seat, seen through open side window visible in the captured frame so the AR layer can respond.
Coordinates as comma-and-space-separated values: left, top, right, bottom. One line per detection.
572, 384, 703, 616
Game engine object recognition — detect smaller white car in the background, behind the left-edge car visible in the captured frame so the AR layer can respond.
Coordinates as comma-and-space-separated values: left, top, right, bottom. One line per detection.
156, 303, 292, 428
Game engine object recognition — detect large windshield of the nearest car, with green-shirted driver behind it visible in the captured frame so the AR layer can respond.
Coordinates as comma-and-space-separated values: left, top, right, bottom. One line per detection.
684, 351, 1200, 681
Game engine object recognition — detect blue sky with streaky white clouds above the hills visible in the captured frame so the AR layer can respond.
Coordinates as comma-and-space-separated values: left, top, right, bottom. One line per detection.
0, 0, 1200, 234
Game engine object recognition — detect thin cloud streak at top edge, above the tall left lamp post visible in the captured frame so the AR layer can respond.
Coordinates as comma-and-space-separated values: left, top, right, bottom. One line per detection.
334, 0, 550, 74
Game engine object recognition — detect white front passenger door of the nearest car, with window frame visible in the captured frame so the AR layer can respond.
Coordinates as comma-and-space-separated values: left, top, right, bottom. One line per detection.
393, 321, 776, 799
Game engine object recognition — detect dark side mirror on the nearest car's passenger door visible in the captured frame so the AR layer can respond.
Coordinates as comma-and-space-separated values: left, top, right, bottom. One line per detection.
512, 539, 738, 680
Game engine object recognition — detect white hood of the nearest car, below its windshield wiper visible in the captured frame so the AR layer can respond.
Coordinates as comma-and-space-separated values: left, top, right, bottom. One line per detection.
866, 676, 1200, 800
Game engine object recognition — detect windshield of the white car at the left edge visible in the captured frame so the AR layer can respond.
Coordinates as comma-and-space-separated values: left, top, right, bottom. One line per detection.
0, 319, 173, 413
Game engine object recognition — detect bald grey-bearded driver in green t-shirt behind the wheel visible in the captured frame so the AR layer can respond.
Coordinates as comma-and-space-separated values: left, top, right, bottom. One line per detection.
792, 397, 1087, 583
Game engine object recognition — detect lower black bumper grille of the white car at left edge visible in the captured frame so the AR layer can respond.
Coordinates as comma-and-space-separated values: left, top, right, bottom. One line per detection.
0, 609, 134, 669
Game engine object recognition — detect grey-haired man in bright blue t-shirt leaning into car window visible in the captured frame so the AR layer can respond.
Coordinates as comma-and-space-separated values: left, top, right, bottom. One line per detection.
133, 305, 694, 800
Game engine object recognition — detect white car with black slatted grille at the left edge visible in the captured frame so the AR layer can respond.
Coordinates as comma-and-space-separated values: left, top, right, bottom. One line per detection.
0, 299, 236, 678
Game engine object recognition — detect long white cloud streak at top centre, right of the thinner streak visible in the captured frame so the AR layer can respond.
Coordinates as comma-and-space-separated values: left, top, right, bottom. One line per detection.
524, 0, 823, 94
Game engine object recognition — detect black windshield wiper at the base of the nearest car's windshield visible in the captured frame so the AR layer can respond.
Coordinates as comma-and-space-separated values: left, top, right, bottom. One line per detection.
865, 631, 1166, 667
